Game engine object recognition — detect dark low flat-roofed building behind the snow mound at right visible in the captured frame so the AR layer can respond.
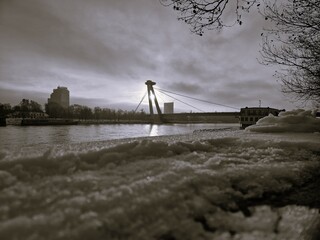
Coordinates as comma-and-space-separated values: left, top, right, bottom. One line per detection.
240, 107, 285, 128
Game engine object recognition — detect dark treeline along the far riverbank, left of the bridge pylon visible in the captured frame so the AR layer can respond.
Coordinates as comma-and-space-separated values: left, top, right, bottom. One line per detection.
0, 99, 149, 121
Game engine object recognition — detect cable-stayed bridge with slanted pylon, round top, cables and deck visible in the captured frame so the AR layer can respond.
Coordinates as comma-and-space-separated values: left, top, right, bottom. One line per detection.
135, 80, 240, 123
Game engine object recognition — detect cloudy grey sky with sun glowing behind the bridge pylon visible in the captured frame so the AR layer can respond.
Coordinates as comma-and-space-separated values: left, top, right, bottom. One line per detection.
0, 0, 299, 112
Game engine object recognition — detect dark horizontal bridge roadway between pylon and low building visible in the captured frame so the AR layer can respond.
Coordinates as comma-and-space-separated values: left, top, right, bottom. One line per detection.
154, 112, 240, 123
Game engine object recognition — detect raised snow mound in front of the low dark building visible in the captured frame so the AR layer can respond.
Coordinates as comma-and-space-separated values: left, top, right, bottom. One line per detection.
246, 109, 320, 132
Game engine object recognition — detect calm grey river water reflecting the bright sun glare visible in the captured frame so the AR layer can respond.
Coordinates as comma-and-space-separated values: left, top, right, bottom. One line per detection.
0, 124, 239, 150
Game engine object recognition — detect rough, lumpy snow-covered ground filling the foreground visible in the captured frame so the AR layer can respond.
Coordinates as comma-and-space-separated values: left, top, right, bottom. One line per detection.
0, 111, 320, 240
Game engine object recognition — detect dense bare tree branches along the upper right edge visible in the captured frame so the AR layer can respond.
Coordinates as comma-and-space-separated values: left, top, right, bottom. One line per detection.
261, 0, 320, 102
